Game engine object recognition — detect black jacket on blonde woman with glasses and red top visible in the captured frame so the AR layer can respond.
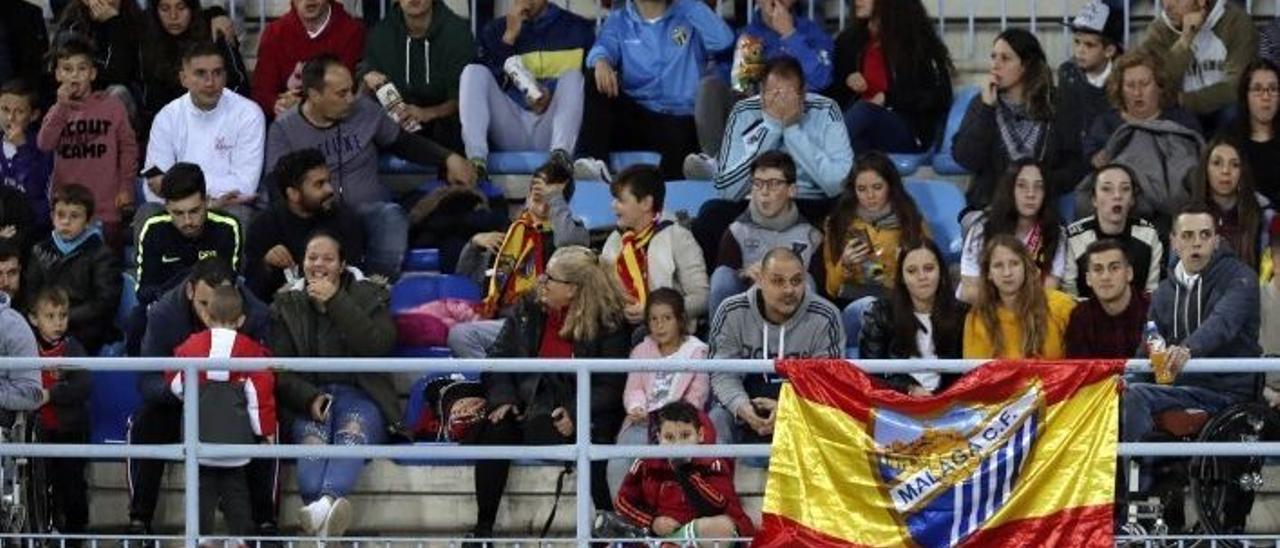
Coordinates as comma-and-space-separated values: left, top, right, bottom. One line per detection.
481, 297, 631, 419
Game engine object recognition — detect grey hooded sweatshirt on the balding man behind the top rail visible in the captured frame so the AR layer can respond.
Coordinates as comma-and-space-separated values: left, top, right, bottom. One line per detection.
709, 286, 845, 412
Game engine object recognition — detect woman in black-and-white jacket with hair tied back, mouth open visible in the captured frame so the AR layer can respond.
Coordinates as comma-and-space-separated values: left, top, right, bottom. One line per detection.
1062, 164, 1165, 298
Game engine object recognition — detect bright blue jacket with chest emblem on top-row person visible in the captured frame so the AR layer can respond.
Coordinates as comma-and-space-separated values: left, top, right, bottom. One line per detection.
586, 0, 733, 117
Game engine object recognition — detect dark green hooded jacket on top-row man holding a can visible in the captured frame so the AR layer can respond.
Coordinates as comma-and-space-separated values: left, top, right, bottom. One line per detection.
360, 1, 476, 106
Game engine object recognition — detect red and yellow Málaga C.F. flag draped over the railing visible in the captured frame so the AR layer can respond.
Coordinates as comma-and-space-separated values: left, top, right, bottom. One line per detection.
753, 360, 1124, 547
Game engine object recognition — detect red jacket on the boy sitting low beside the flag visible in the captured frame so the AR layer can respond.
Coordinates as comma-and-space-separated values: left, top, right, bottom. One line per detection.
614, 458, 755, 536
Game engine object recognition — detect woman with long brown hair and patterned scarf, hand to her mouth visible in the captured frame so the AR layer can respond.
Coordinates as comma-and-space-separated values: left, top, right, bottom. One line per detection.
951, 28, 1084, 211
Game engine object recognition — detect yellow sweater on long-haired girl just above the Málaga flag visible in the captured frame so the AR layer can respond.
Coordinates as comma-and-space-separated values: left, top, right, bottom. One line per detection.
964, 289, 1075, 360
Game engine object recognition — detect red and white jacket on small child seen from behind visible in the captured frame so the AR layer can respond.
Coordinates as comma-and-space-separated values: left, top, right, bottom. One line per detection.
165, 329, 276, 437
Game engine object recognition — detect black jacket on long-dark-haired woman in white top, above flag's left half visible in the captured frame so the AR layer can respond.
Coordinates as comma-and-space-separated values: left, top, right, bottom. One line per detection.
858, 298, 968, 392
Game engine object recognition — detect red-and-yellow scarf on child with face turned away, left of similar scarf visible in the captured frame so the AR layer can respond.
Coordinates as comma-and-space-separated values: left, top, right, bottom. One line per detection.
480, 210, 547, 318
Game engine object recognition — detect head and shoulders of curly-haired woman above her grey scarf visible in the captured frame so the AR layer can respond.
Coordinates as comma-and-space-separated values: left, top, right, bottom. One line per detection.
1083, 50, 1201, 168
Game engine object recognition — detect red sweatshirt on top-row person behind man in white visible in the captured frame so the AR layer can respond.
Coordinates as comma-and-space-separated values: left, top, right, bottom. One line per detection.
251, 0, 365, 119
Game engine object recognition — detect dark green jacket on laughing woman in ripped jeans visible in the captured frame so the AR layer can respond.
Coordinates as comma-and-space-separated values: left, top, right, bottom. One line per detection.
271, 273, 402, 431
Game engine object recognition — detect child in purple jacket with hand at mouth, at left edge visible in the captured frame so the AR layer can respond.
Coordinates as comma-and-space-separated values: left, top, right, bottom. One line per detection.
0, 79, 54, 238
